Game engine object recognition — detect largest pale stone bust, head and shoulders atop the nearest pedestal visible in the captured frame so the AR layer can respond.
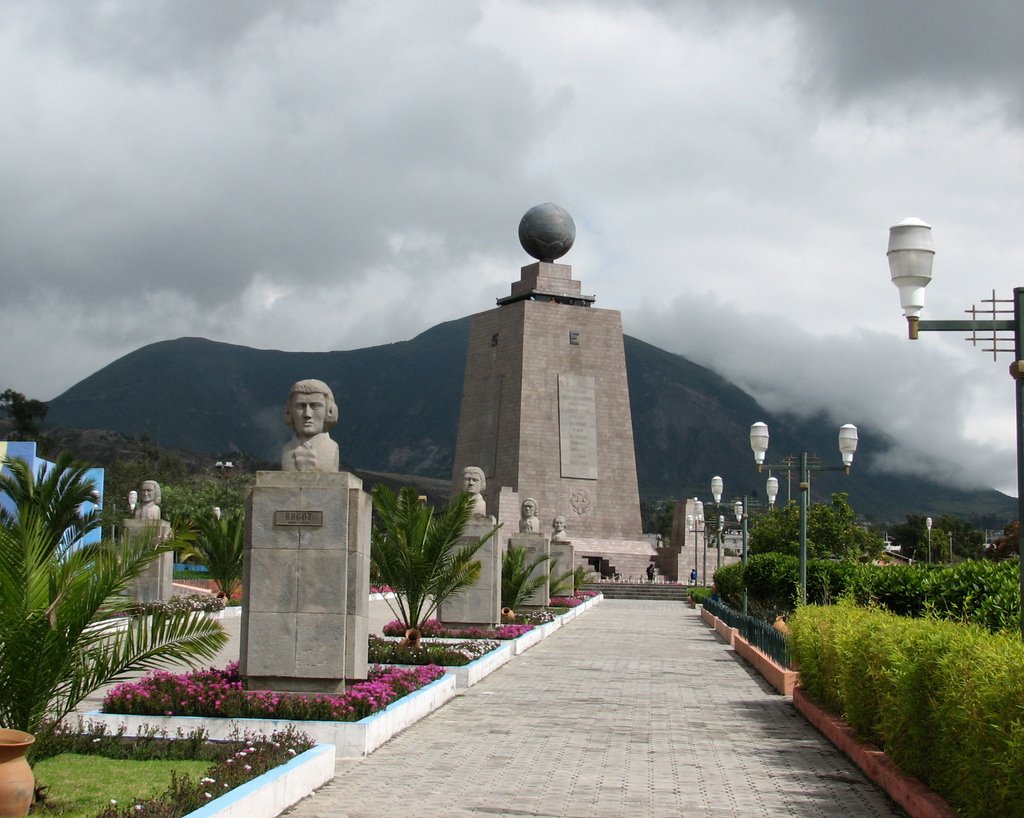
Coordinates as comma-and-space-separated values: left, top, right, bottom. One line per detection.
281, 379, 339, 472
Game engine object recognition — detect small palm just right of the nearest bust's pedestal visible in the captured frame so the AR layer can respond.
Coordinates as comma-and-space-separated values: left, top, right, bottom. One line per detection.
371, 484, 498, 629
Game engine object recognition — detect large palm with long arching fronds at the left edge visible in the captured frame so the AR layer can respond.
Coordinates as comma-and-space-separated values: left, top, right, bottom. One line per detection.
0, 456, 227, 733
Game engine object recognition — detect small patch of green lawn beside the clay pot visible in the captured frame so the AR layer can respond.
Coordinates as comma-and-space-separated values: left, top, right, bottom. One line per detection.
32, 752, 212, 818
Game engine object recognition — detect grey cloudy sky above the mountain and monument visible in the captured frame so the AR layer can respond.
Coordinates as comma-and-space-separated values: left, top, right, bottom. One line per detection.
0, 0, 1024, 493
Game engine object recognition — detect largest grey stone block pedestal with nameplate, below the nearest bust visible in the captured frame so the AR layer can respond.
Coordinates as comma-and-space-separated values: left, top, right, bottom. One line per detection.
239, 472, 372, 693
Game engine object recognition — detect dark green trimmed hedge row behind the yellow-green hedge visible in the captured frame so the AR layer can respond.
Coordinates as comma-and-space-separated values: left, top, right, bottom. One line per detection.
715, 553, 1021, 632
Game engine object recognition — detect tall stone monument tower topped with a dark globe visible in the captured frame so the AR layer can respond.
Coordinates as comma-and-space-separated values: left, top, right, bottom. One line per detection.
453, 204, 652, 573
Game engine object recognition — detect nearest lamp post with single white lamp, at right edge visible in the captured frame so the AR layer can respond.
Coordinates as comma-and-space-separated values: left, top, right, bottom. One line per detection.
886, 218, 1024, 636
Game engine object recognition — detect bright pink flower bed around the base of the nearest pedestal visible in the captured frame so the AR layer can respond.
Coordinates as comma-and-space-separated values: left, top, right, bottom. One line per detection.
102, 662, 444, 722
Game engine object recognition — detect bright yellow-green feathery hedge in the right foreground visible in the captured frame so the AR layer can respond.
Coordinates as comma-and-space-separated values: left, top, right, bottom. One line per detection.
790, 602, 1024, 818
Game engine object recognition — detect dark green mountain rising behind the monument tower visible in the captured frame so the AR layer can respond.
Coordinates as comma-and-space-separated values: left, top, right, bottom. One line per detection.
47, 316, 1016, 525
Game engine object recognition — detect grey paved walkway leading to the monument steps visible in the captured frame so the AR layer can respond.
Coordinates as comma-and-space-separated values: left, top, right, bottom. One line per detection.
286, 600, 903, 818
